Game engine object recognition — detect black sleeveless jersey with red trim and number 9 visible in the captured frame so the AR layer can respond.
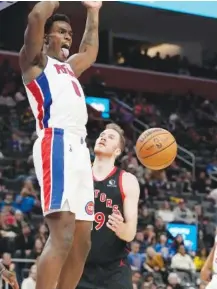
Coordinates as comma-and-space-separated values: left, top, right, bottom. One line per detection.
87, 167, 128, 264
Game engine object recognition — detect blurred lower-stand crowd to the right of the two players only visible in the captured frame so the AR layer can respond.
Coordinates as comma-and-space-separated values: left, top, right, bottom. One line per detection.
86, 71, 217, 289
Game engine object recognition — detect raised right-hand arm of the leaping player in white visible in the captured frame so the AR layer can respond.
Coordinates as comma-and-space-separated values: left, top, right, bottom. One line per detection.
67, 1, 102, 77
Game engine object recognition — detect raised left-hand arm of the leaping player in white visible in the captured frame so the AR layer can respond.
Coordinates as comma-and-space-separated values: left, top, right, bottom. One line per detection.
20, 1, 59, 70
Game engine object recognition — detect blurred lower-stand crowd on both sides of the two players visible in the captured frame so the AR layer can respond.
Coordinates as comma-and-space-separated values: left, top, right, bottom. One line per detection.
0, 54, 217, 289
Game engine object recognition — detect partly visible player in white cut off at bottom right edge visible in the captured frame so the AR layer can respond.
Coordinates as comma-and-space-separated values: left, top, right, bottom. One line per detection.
200, 234, 217, 289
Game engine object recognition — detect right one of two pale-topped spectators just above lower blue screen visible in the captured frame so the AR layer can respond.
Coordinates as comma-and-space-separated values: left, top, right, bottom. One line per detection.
173, 199, 196, 224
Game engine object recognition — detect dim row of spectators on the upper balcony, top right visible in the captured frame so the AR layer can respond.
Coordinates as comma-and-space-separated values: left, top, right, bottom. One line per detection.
114, 39, 217, 79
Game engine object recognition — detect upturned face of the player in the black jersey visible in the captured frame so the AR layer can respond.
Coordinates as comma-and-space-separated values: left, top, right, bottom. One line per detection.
94, 129, 121, 158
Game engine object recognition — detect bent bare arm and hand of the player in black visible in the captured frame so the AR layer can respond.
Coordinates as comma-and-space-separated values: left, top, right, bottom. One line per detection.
107, 173, 140, 242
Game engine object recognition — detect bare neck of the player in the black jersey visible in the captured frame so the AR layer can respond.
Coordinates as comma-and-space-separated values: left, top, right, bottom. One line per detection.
93, 157, 115, 179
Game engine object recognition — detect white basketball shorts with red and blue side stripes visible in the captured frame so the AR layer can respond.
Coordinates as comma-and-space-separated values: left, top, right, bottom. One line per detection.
33, 128, 94, 221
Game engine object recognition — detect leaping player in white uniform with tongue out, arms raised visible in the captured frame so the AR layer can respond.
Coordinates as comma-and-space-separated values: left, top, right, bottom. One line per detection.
19, 1, 102, 289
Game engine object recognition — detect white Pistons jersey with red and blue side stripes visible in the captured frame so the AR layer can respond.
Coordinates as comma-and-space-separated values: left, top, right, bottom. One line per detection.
24, 57, 88, 136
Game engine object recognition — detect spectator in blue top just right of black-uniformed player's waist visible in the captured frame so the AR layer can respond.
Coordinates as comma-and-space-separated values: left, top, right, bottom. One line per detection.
128, 241, 144, 271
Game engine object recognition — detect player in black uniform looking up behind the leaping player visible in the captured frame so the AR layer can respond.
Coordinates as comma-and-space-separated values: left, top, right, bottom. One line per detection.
57, 124, 139, 289
